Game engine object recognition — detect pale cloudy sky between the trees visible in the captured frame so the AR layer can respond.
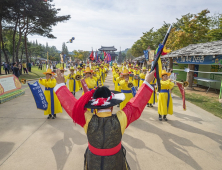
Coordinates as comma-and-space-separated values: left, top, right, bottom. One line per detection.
29, 0, 222, 51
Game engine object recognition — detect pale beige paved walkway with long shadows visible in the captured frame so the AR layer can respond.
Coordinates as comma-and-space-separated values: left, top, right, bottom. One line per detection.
0, 73, 222, 170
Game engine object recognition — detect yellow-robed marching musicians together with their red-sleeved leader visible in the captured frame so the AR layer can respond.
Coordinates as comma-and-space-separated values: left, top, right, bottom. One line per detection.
39, 62, 174, 170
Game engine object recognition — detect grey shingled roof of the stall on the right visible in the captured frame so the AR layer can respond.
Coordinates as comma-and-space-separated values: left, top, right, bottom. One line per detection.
161, 40, 222, 58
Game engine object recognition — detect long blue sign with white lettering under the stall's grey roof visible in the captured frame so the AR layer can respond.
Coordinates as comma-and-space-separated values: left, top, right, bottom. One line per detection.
174, 55, 222, 65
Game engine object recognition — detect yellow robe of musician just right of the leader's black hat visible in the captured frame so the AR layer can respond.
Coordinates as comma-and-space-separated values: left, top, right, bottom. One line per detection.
119, 80, 133, 110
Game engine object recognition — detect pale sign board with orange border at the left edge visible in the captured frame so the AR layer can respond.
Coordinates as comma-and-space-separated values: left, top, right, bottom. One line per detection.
0, 75, 22, 96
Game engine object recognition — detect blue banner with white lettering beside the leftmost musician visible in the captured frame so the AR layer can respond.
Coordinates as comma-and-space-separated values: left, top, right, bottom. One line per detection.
28, 81, 48, 110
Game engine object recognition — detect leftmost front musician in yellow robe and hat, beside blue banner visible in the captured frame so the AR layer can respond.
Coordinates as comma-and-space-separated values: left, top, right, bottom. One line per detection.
39, 69, 62, 119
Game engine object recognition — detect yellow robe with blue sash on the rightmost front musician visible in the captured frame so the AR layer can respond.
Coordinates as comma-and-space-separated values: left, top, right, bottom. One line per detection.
158, 80, 174, 115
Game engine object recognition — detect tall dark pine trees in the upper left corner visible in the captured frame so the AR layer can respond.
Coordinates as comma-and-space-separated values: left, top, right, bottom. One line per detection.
0, 0, 70, 68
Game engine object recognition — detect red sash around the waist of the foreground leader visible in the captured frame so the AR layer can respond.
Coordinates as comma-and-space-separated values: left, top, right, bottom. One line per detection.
88, 142, 122, 156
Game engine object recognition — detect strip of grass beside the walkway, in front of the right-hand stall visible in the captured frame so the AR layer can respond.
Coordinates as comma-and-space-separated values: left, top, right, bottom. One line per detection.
173, 87, 222, 118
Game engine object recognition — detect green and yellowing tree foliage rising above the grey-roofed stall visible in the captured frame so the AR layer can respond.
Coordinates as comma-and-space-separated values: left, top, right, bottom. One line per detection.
131, 9, 222, 57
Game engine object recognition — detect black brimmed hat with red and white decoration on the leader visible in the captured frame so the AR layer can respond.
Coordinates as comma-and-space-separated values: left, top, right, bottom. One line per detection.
85, 86, 125, 109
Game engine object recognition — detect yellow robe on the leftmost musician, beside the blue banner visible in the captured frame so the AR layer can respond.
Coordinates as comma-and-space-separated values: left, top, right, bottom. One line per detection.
39, 79, 62, 115
